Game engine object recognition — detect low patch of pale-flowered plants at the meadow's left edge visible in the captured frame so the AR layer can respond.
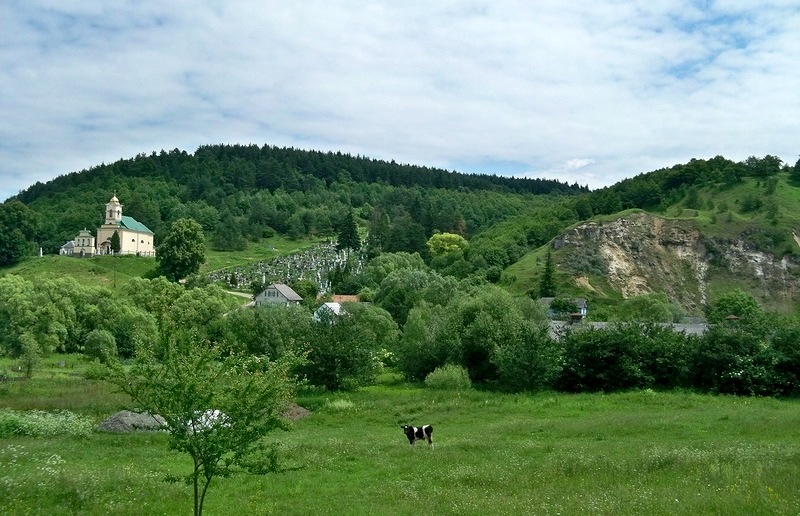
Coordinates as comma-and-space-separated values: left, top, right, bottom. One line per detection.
0, 409, 93, 437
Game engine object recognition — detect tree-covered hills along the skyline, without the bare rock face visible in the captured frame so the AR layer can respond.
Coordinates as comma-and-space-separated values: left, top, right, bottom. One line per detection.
6, 145, 800, 306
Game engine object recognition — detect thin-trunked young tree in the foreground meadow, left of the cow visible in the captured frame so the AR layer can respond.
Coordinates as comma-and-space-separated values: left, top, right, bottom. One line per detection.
106, 330, 297, 516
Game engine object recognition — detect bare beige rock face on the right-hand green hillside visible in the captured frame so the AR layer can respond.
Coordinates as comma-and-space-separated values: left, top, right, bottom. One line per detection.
553, 213, 800, 311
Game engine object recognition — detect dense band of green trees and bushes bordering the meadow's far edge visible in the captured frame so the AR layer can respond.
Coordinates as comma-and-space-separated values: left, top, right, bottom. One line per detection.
0, 253, 800, 396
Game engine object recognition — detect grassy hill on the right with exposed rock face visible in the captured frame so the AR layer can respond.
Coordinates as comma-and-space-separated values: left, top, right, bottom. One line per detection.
503, 171, 800, 316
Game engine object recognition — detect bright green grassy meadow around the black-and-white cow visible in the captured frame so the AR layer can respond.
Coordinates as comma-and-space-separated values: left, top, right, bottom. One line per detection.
0, 356, 800, 515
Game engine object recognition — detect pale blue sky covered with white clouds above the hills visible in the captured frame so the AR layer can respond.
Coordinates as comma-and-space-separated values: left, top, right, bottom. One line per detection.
0, 0, 800, 201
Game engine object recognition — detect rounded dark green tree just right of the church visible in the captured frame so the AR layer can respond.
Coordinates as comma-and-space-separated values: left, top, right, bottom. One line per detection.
156, 219, 206, 281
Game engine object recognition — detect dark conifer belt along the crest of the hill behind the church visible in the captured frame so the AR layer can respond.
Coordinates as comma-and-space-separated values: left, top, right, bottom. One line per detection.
15, 145, 588, 204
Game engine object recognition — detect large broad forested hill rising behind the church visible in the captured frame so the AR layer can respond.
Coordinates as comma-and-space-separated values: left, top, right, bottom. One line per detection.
7, 145, 588, 256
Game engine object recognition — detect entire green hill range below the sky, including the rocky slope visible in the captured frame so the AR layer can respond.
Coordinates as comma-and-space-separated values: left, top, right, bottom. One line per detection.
0, 145, 800, 315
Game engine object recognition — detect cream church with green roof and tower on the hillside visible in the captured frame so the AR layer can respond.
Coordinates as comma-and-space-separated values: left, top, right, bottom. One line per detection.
61, 195, 156, 258
